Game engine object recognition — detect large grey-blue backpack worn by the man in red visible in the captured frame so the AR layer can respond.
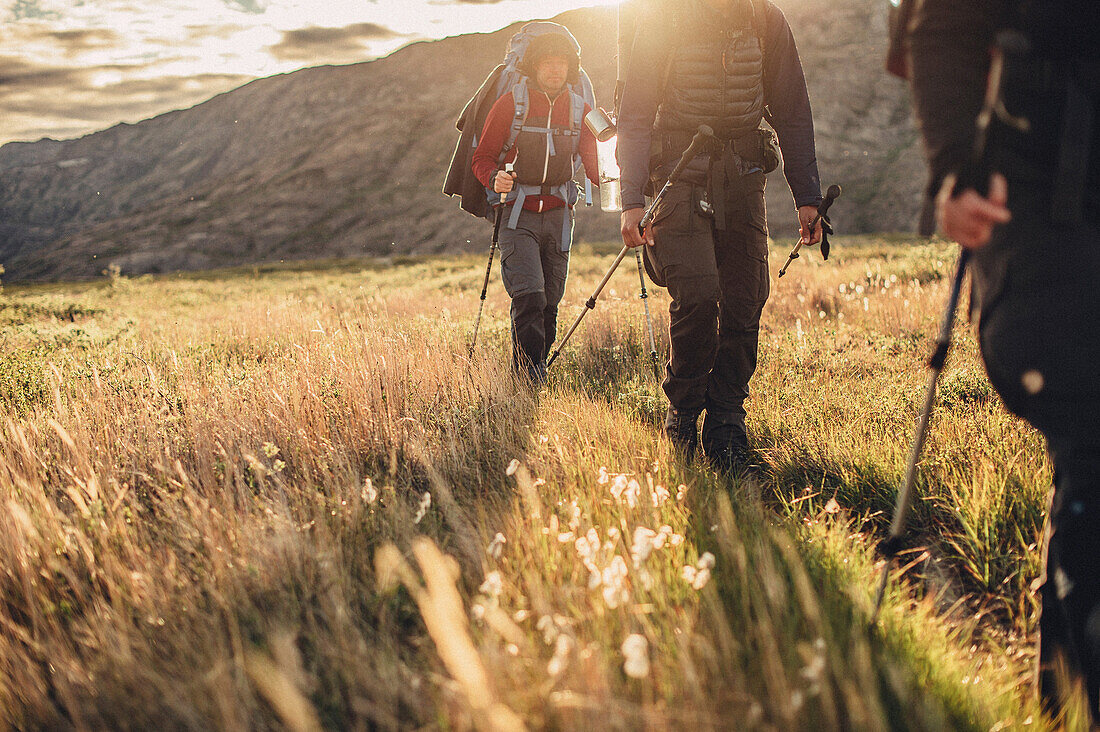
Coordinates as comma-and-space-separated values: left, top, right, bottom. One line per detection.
443, 21, 596, 217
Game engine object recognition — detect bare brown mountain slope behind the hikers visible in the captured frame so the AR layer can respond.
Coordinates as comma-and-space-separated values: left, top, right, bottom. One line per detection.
0, 0, 922, 281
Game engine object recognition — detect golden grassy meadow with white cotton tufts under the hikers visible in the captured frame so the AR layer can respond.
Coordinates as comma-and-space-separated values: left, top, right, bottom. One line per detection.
0, 237, 1080, 730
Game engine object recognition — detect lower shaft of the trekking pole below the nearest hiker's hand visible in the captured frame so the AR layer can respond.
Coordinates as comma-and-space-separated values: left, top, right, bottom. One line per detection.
871, 249, 970, 626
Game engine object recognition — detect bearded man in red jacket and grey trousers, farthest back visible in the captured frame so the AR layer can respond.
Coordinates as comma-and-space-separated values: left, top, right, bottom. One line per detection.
472, 34, 597, 383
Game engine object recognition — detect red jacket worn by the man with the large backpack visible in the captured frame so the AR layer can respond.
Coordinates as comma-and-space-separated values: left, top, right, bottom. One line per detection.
471, 84, 598, 211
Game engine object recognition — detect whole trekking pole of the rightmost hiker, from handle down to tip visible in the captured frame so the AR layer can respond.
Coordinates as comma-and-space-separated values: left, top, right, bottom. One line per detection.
871, 31, 1030, 626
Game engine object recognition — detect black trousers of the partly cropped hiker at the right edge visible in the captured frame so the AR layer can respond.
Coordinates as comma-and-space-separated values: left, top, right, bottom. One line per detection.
974, 177, 1100, 721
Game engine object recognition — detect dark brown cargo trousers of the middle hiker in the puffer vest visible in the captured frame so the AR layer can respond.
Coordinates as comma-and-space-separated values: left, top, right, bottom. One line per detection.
645, 172, 770, 452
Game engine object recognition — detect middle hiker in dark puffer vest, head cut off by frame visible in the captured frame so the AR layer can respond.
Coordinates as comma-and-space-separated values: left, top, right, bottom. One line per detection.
618, 0, 822, 469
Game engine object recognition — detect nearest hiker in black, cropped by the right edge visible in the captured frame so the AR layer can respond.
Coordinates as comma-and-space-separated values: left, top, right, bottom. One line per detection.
909, 0, 1100, 724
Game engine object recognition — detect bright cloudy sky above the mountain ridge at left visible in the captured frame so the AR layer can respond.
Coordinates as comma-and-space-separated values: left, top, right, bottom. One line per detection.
0, 0, 618, 144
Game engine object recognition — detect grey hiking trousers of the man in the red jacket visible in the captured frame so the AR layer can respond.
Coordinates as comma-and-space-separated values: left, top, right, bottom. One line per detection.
499, 206, 573, 382
